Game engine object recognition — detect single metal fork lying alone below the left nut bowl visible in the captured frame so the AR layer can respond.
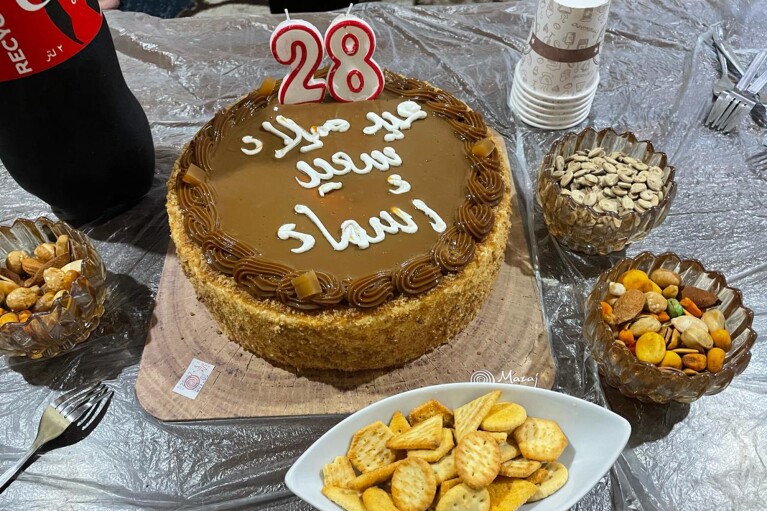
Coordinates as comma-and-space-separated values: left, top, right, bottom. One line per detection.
0, 382, 113, 489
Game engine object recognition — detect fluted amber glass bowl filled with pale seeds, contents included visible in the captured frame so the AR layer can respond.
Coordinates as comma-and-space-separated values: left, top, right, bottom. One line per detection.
536, 128, 676, 255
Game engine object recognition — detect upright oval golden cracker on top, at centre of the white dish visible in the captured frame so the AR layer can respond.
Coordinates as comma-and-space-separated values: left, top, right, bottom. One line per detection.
455, 431, 501, 489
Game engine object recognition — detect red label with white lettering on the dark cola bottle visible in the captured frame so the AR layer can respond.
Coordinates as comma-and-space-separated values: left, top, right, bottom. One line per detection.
0, 0, 103, 82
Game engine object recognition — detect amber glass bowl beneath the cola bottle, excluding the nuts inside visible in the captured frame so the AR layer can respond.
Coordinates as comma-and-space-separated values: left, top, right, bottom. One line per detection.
0, 218, 106, 359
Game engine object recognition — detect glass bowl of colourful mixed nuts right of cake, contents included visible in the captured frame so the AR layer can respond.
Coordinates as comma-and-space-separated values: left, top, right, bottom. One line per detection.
583, 252, 756, 403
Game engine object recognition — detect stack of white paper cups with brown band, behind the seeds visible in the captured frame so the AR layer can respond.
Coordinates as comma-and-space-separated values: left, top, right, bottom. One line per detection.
509, 0, 610, 130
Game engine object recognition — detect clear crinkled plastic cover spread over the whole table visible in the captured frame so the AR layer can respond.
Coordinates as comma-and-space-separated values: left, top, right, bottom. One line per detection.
0, 0, 767, 510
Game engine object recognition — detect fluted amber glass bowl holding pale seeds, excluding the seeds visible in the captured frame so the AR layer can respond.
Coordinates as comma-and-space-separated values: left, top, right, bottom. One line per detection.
536, 128, 676, 255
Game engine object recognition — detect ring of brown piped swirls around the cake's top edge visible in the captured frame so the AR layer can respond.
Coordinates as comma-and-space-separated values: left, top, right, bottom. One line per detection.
176, 71, 504, 310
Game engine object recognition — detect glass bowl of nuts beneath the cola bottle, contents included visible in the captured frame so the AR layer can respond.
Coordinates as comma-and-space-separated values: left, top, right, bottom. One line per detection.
0, 218, 106, 358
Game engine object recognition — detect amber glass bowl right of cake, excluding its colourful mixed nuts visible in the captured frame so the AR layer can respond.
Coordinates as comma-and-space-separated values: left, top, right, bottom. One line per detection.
583, 252, 756, 403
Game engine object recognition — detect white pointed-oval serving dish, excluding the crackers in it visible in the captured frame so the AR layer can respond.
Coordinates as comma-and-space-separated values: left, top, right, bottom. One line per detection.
285, 383, 631, 511
